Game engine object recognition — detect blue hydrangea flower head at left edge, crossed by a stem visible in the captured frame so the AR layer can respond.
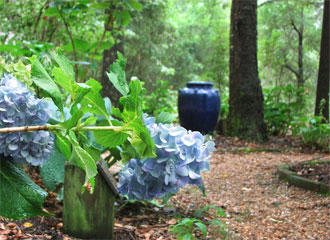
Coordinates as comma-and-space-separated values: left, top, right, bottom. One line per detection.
0, 75, 54, 166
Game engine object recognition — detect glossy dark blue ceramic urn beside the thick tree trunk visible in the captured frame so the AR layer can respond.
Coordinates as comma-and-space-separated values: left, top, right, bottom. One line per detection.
178, 82, 221, 133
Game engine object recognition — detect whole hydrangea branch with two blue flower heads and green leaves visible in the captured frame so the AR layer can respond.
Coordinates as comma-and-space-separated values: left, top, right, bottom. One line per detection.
0, 52, 214, 219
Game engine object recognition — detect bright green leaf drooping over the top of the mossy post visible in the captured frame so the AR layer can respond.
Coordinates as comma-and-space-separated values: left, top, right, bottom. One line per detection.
70, 140, 98, 187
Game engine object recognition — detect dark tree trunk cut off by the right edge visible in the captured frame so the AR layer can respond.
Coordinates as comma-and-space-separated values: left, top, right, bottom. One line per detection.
315, 0, 330, 121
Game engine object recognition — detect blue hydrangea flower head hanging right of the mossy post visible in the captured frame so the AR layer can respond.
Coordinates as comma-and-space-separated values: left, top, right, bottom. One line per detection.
118, 114, 215, 201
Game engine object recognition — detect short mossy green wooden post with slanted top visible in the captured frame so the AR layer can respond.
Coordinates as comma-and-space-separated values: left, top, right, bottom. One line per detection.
63, 161, 118, 239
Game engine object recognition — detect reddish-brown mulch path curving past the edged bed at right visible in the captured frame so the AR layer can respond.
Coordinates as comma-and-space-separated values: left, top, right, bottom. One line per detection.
170, 136, 330, 239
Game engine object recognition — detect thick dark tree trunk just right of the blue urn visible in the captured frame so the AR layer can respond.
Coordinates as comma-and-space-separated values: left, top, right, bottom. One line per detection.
227, 0, 267, 141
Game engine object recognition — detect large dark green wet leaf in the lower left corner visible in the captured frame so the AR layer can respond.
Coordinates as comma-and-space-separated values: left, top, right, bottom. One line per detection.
0, 156, 49, 219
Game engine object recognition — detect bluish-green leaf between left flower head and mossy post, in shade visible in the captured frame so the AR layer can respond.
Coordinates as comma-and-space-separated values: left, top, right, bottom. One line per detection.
40, 147, 66, 192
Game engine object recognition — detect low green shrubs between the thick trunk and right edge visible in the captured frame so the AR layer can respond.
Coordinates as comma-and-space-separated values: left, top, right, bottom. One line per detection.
264, 84, 330, 150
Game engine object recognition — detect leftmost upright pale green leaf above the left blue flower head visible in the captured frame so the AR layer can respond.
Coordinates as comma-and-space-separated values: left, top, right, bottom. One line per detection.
30, 56, 63, 112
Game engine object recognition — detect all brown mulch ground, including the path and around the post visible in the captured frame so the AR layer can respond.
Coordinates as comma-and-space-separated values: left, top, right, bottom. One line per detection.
0, 136, 330, 240
